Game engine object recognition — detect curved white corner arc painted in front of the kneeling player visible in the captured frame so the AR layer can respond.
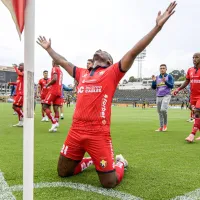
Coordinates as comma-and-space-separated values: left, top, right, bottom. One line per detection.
10, 182, 142, 200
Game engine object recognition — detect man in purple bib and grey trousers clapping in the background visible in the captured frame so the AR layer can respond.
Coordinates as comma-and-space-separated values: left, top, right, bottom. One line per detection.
152, 64, 174, 131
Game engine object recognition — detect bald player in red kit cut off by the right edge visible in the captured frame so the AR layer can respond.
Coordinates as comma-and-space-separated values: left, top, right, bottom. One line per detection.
173, 53, 200, 142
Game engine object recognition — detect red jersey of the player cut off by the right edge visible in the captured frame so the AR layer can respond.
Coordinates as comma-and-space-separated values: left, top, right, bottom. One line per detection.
186, 67, 200, 100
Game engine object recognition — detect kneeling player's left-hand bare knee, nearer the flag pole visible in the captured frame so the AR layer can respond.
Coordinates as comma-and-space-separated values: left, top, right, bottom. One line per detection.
57, 155, 80, 177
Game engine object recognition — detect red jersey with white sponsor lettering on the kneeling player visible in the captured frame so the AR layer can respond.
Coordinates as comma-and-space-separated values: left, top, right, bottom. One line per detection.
72, 62, 125, 131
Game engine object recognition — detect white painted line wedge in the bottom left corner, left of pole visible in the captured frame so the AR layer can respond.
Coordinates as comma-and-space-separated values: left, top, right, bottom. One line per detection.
0, 171, 16, 200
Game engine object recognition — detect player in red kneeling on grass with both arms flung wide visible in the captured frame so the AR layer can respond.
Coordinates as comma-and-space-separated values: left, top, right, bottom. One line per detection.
38, 2, 176, 188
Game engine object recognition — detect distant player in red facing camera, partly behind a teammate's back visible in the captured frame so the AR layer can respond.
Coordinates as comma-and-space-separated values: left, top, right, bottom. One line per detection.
38, 70, 51, 122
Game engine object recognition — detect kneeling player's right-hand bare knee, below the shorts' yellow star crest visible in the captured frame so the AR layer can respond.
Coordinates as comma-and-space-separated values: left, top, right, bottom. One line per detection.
98, 171, 117, 188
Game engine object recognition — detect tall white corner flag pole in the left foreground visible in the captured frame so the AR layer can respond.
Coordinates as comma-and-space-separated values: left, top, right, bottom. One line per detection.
23, 0, 35, 200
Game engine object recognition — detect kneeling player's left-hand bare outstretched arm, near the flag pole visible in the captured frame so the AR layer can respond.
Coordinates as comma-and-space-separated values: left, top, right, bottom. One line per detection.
37, 36, 74, 76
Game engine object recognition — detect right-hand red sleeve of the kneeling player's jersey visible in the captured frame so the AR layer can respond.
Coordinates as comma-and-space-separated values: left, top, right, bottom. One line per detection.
109, 61, 126, 85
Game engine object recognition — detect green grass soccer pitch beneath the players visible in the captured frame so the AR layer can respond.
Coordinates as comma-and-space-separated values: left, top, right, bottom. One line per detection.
0, 103, 200, 200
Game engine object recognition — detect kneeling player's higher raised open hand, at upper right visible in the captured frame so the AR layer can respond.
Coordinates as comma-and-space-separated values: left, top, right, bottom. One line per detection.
156, 1, 177, 28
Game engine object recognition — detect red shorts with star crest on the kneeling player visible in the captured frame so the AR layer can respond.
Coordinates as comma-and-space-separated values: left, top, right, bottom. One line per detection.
60, 127, 115, 173
